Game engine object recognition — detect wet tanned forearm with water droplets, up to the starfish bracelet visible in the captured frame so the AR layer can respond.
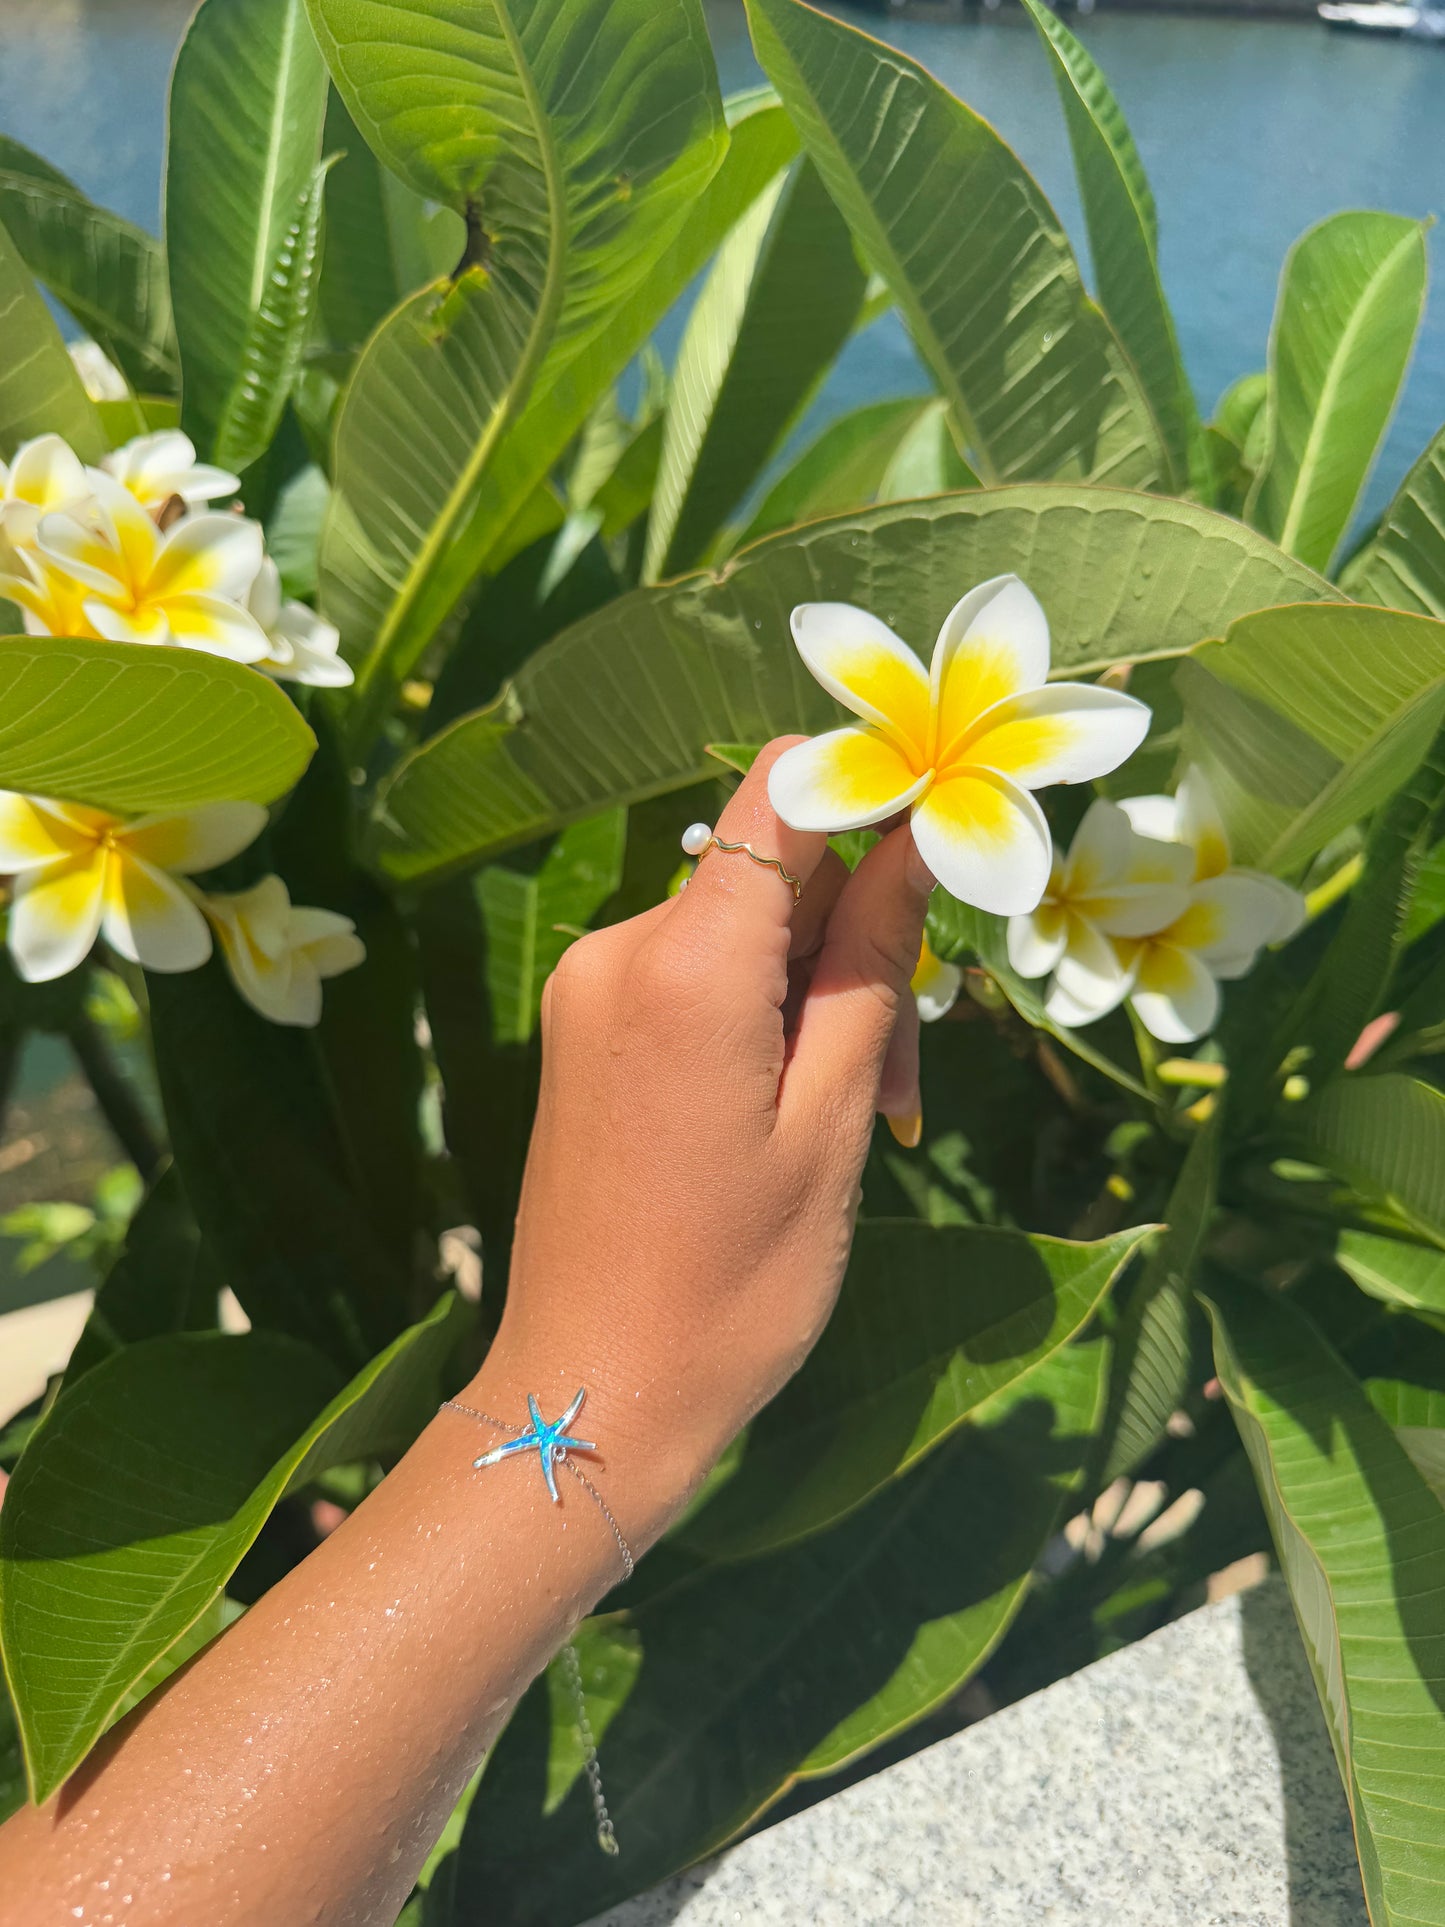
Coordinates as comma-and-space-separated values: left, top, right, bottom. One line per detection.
0, 1347, 690, 1927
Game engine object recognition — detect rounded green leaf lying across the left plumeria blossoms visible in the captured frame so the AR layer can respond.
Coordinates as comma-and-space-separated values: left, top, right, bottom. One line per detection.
0, 636, 316, 815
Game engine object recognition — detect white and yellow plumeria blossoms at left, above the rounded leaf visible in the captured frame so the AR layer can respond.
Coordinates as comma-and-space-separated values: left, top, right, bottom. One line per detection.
0, 430, 351, 688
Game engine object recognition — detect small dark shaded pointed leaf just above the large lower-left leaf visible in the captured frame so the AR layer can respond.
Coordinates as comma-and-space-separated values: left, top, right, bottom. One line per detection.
66, 1166, 225, 1386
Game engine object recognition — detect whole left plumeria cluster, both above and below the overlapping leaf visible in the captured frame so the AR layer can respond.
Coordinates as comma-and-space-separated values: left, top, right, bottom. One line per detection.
0, 430, 366, 1025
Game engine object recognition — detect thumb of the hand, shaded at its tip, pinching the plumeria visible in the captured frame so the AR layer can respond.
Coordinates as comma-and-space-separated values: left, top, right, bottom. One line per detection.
780, 825, 933, 1127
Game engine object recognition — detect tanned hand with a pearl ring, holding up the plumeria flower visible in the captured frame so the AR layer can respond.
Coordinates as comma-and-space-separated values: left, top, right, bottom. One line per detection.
475, 738, 933, 1549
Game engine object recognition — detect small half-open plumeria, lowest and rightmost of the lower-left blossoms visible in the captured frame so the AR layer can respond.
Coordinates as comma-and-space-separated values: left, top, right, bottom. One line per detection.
204, 877, 366, 1027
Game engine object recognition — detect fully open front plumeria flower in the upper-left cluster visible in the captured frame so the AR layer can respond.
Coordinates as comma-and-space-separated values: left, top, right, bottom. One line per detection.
33, 468, 270, 663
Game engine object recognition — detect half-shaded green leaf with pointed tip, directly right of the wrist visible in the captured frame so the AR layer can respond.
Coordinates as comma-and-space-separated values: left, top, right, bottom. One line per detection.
678, 1220, 1148, 1559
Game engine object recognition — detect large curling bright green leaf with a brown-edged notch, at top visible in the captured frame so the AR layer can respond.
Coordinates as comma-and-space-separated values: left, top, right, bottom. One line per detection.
308, 0, 728, 730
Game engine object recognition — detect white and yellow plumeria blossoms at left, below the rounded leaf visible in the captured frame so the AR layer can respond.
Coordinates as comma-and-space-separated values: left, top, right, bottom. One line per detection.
0, 790, 366, 1025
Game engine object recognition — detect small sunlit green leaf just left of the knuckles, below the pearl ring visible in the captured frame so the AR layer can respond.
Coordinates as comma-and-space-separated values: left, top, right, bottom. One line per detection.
476, 809, 626, 1044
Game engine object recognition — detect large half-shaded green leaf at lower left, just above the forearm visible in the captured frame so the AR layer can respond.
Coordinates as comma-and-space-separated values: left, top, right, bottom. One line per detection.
0, 1297, 466, 1800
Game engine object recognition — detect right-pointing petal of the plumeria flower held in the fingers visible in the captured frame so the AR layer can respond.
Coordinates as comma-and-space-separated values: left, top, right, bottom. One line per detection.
938, 682, 1150, 790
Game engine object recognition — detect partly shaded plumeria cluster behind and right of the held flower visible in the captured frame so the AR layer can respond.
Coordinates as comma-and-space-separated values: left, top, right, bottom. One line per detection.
1008, 769, 1304, 1044
